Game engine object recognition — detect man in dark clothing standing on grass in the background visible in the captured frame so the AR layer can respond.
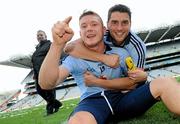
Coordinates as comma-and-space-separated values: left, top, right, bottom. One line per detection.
32, 30, 62, 115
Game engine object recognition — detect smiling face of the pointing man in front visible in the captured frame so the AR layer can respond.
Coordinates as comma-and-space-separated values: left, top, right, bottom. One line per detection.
79, 14, 106, 48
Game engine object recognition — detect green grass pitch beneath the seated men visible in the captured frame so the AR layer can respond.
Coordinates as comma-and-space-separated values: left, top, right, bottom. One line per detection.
0, 99, 180, 124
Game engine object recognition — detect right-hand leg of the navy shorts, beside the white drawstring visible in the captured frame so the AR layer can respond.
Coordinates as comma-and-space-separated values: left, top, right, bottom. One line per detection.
110, 84, 157, 121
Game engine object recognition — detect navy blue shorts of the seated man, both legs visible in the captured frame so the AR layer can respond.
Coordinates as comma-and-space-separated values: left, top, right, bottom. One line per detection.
71, 84, 157, 124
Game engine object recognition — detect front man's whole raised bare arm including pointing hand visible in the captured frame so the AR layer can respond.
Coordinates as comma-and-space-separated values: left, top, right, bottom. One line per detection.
39, 17, 74, 89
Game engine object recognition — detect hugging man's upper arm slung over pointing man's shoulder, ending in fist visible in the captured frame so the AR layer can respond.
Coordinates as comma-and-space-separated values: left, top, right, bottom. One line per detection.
64, 39, 119, 68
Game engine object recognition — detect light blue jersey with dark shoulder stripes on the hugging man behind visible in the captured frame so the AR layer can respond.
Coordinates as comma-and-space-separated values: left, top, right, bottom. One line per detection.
104, 30, 146, 68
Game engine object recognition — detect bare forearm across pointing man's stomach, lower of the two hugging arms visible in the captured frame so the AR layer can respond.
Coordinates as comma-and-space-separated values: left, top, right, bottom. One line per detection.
90, 77, 136, 90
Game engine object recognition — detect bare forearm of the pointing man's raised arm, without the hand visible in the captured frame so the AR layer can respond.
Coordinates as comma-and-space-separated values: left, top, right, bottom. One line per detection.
39, 43, 64, 89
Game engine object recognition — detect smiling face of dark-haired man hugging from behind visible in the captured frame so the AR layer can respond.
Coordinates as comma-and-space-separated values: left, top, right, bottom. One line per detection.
107, 11, 131, 45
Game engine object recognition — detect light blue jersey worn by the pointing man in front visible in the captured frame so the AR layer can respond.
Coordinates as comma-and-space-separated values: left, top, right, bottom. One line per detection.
62, 48, 129, 100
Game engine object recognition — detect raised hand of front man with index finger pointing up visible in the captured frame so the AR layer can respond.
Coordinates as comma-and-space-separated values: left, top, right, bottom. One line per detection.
52, 16, 74, 45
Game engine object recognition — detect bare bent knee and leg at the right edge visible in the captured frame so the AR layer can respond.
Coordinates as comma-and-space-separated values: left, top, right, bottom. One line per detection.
150, 77, 180, 115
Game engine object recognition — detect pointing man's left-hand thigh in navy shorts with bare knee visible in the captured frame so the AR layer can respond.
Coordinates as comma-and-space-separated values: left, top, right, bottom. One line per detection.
68, 93, 111, 124
